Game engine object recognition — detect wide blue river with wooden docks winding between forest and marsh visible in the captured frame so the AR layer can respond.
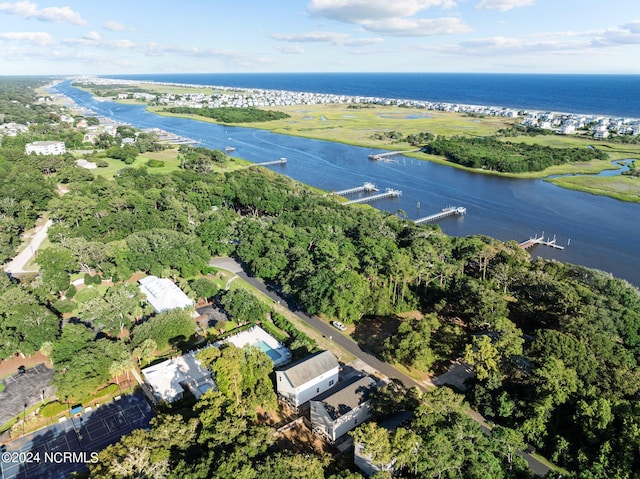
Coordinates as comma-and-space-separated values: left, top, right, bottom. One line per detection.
55, 82, 640, 286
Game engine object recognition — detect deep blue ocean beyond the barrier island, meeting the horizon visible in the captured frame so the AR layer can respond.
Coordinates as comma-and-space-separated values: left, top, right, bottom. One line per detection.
108, 73, 640, 118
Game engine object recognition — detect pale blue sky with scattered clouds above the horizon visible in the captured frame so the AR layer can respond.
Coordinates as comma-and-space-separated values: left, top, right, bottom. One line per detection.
0, 0, 640, 75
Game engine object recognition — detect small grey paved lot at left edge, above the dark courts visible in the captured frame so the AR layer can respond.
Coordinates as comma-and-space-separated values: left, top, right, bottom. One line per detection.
0, 364, 53, 424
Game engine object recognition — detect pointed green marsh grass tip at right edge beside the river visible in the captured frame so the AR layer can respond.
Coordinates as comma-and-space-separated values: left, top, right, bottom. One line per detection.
548, 176, 640, 203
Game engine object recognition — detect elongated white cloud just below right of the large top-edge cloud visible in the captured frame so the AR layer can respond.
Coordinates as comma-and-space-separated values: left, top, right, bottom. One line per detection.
362, 17, 472, 37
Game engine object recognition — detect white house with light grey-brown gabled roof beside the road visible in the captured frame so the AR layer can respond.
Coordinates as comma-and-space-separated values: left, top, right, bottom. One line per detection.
276, 351, 340, 407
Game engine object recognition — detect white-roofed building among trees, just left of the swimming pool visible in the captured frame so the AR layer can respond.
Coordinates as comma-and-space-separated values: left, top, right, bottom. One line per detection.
142, 352, 216, 403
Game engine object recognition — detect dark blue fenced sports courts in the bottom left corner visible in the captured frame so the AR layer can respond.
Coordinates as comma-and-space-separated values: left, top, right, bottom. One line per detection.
0, 394, 153, 479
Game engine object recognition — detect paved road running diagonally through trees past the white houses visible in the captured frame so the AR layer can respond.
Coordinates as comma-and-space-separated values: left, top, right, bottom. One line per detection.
209, 258, 549, 476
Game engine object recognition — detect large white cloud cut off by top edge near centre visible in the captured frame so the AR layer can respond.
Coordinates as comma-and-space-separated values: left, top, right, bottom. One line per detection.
308, 0, 455, 24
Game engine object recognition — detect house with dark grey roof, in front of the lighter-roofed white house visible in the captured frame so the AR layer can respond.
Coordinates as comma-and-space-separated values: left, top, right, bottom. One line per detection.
311, 376, 376, 441
